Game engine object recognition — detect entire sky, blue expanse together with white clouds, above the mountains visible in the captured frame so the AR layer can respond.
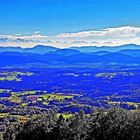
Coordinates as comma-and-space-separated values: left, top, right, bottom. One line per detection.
0, 0, 140, 48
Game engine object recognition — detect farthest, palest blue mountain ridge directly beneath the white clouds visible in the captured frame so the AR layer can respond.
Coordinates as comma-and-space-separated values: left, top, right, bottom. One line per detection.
0, 44, 140, 55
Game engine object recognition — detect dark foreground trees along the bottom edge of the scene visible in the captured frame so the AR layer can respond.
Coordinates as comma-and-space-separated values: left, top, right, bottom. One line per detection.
0, 108, 140, 140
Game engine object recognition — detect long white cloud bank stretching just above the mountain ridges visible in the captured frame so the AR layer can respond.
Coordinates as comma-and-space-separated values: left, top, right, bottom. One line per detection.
0, 26, 140, 48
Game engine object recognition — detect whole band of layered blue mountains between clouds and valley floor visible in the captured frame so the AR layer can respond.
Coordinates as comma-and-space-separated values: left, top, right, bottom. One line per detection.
0, 44, 140, 67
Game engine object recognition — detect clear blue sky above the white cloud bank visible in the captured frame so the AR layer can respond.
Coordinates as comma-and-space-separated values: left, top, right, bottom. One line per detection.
0, 0, 140, 35
